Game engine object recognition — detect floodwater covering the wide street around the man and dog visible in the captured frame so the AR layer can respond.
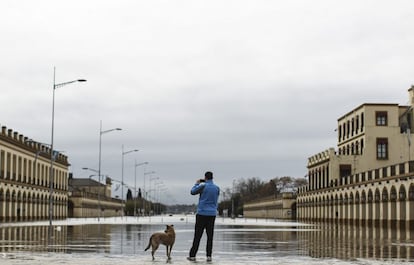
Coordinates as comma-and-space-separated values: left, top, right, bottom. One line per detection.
0, 217, 414, 265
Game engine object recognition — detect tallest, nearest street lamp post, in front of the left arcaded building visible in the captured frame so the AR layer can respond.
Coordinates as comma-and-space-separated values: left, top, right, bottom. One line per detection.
49, 67, 86, 229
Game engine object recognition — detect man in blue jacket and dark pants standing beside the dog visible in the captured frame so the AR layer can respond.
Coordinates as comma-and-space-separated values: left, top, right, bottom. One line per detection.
187, 171, 220, 262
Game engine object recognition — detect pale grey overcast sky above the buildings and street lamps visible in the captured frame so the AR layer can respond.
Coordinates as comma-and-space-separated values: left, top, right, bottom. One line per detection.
0, 0, 414, 204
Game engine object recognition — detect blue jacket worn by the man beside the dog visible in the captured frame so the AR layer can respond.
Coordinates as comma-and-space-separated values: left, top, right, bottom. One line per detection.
191, 180, 220, 216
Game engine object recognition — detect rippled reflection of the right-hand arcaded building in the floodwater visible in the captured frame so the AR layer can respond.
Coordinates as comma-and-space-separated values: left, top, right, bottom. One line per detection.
298, 221, 414, 261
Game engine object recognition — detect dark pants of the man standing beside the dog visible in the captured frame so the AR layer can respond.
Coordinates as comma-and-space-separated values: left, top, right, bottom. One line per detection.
190, 214, 216, 257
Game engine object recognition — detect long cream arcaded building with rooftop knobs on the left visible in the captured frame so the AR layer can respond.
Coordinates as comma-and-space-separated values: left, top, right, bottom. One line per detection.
0, 126, 69, 221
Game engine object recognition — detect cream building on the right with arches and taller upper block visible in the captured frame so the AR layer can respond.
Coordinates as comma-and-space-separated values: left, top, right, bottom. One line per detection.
297, 87, 414, 223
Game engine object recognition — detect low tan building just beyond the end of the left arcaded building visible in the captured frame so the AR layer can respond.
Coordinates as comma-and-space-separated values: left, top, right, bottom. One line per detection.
68, 176, 124, 217
